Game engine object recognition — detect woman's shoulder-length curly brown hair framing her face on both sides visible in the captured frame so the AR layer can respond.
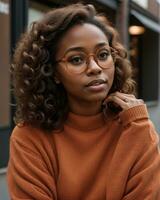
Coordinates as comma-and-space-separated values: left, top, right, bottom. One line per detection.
11, 3, 134, 131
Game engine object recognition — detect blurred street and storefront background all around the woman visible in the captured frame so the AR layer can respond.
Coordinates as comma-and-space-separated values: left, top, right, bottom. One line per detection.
0, 0, 160, 200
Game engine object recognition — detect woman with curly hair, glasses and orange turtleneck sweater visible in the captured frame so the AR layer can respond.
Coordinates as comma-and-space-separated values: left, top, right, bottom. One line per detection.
7, 4, 160, 200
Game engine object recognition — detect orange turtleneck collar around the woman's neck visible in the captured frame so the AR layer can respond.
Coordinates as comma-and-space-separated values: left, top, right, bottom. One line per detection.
66, 112, 106, 131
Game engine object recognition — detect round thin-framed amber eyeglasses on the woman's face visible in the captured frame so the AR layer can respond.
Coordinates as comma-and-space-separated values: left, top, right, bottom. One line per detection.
56, 47, 113, 74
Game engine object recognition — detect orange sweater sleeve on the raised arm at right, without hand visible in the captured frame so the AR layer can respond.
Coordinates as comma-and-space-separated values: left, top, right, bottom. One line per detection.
121, 107, 160, 200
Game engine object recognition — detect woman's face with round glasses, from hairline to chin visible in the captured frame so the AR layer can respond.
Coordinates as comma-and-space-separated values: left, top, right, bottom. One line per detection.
56, 23, 115, 110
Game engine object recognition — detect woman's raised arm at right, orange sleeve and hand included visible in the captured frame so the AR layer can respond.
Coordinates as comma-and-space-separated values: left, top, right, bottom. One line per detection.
106, 92, 160, 200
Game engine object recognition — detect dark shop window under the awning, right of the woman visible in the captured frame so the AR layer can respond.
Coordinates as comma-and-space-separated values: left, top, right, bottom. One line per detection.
130, 11, 160, 105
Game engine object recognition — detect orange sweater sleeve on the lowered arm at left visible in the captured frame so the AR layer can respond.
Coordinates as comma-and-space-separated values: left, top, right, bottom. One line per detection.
7, 128, 57, 200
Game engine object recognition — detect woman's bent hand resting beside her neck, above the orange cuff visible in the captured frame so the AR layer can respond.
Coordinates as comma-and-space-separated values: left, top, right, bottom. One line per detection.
103, 92, 144, 110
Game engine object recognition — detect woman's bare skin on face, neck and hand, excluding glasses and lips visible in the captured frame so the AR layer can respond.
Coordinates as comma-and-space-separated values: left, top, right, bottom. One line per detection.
55, 23, 142, 115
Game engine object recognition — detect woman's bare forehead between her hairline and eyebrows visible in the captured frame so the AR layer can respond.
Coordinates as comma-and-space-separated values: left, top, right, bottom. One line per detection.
58, 23, 108, 54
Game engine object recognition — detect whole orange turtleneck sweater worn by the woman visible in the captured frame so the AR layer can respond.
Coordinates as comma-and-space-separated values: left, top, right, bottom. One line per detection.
7, 105, 160, 200
